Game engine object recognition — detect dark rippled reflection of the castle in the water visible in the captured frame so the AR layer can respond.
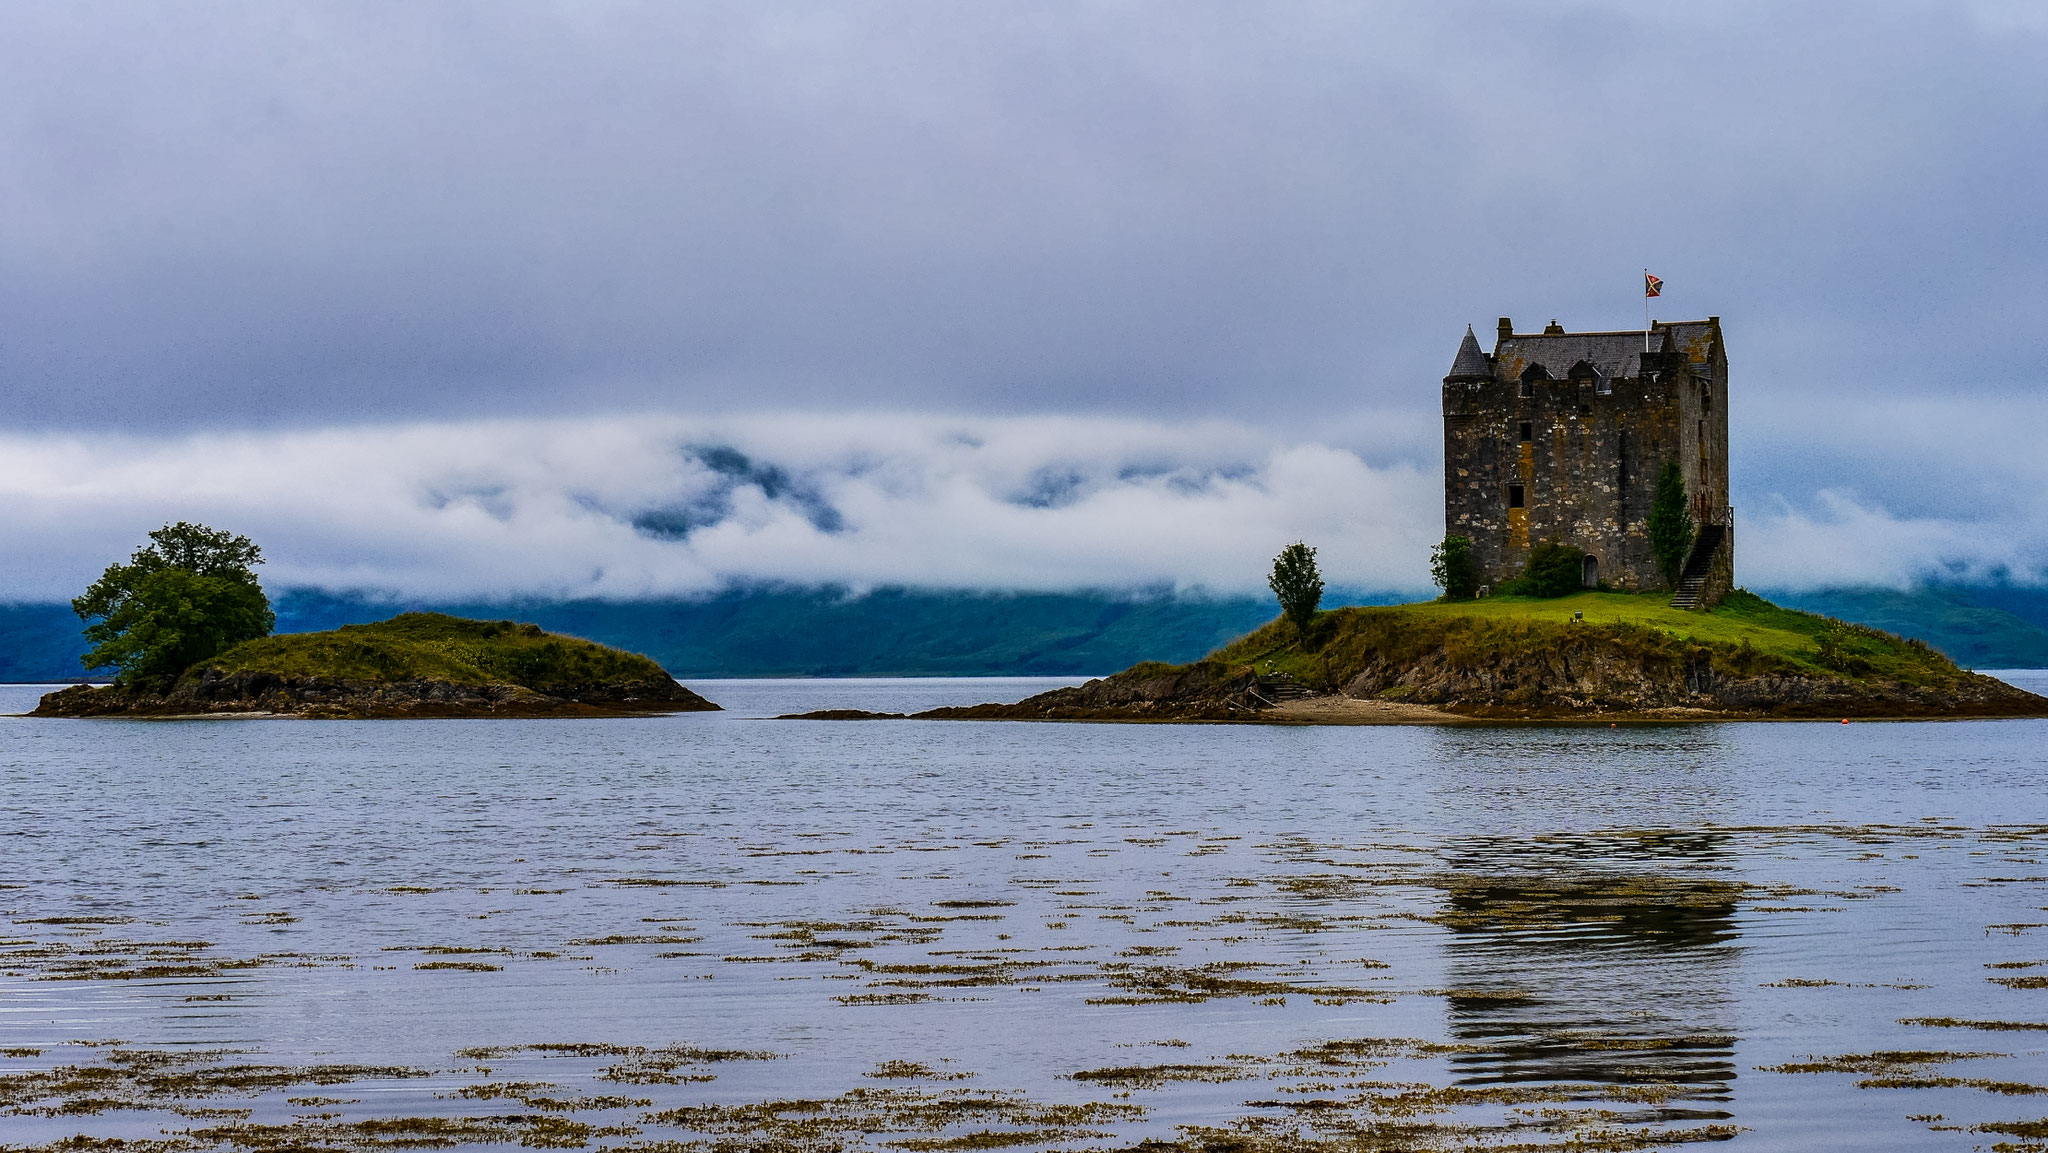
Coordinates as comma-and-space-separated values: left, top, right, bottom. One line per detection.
1438, 829, 1743, 1118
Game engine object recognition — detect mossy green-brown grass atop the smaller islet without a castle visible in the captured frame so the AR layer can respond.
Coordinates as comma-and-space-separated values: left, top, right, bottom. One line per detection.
184, 612, 668, 692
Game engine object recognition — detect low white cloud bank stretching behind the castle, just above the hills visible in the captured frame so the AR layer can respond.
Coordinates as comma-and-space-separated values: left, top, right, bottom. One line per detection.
0, 414, 2048, 600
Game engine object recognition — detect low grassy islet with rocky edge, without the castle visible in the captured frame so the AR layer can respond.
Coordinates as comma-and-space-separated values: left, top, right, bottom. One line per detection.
31, 612, 719, 719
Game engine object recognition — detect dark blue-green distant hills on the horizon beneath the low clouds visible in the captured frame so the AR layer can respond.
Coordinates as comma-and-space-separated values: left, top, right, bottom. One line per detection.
12, 586, 2048, 682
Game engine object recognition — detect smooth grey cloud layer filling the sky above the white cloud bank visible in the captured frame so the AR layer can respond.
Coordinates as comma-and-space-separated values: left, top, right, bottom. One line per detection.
0, 0, 2048, 432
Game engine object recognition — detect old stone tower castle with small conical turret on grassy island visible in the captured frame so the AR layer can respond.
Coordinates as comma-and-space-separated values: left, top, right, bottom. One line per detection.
1444, 315, 1735, 608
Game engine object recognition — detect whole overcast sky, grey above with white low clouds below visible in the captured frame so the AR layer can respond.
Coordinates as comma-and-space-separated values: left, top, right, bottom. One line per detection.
0, 0, 2048, 598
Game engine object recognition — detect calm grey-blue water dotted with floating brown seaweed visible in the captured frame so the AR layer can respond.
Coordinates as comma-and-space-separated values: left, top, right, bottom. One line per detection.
0, 674, 2048, 1151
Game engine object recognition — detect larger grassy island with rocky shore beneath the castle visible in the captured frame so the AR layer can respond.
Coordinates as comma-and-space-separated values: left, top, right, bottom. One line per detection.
794, 590, 2048, 725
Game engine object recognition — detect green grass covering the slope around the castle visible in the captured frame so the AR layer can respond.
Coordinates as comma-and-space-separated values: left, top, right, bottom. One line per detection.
1204, 590, 1966, 688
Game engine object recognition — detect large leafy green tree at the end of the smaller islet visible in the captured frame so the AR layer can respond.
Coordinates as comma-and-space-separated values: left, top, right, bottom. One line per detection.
72, 520, 276, 690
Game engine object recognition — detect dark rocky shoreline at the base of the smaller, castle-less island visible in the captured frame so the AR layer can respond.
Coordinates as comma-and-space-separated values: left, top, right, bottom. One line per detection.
29, 668, 719, 719
